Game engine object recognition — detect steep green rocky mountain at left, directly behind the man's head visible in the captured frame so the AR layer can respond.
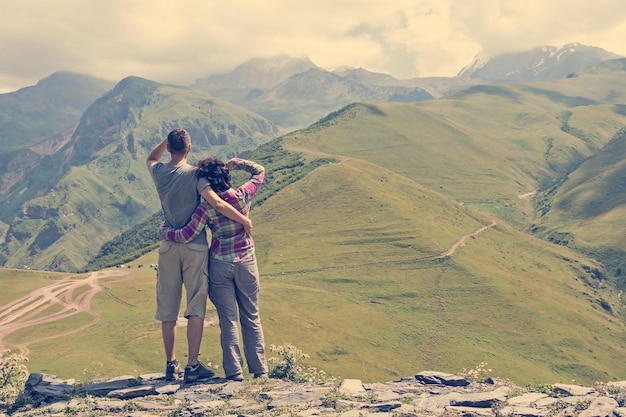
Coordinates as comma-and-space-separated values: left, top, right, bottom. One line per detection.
0, 77, 276, 271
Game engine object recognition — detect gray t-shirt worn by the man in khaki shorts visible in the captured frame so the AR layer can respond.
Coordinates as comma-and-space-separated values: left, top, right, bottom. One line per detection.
150, 162, 208, 244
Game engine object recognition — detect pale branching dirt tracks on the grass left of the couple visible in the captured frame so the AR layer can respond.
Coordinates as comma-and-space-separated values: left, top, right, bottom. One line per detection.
0, 269, 128, 356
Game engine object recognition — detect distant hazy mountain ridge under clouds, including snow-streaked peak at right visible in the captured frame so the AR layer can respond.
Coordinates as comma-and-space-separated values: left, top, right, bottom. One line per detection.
193, 43, 618, 132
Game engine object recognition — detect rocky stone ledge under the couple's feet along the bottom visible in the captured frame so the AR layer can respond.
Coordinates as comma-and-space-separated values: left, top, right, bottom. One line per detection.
0, 371, 626, 417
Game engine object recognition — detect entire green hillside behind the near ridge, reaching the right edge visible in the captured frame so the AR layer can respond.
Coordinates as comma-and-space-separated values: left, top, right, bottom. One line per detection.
285, 72, 626, 271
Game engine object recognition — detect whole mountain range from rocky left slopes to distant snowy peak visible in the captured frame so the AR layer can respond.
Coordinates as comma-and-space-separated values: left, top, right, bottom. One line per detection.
0, 44, 615, 270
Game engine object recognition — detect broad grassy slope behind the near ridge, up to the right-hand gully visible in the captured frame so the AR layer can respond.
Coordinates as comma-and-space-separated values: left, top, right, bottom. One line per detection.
288, 73, 626, 234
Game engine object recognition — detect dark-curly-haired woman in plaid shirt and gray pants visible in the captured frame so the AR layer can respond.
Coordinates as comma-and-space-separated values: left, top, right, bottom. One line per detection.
161, 157, 268, 381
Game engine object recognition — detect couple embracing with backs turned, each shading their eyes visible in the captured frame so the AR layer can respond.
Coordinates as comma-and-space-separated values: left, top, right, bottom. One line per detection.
146, 129, 268, 382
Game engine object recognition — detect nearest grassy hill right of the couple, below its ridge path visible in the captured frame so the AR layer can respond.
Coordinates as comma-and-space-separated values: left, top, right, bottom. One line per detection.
246, 158, 625, 383
